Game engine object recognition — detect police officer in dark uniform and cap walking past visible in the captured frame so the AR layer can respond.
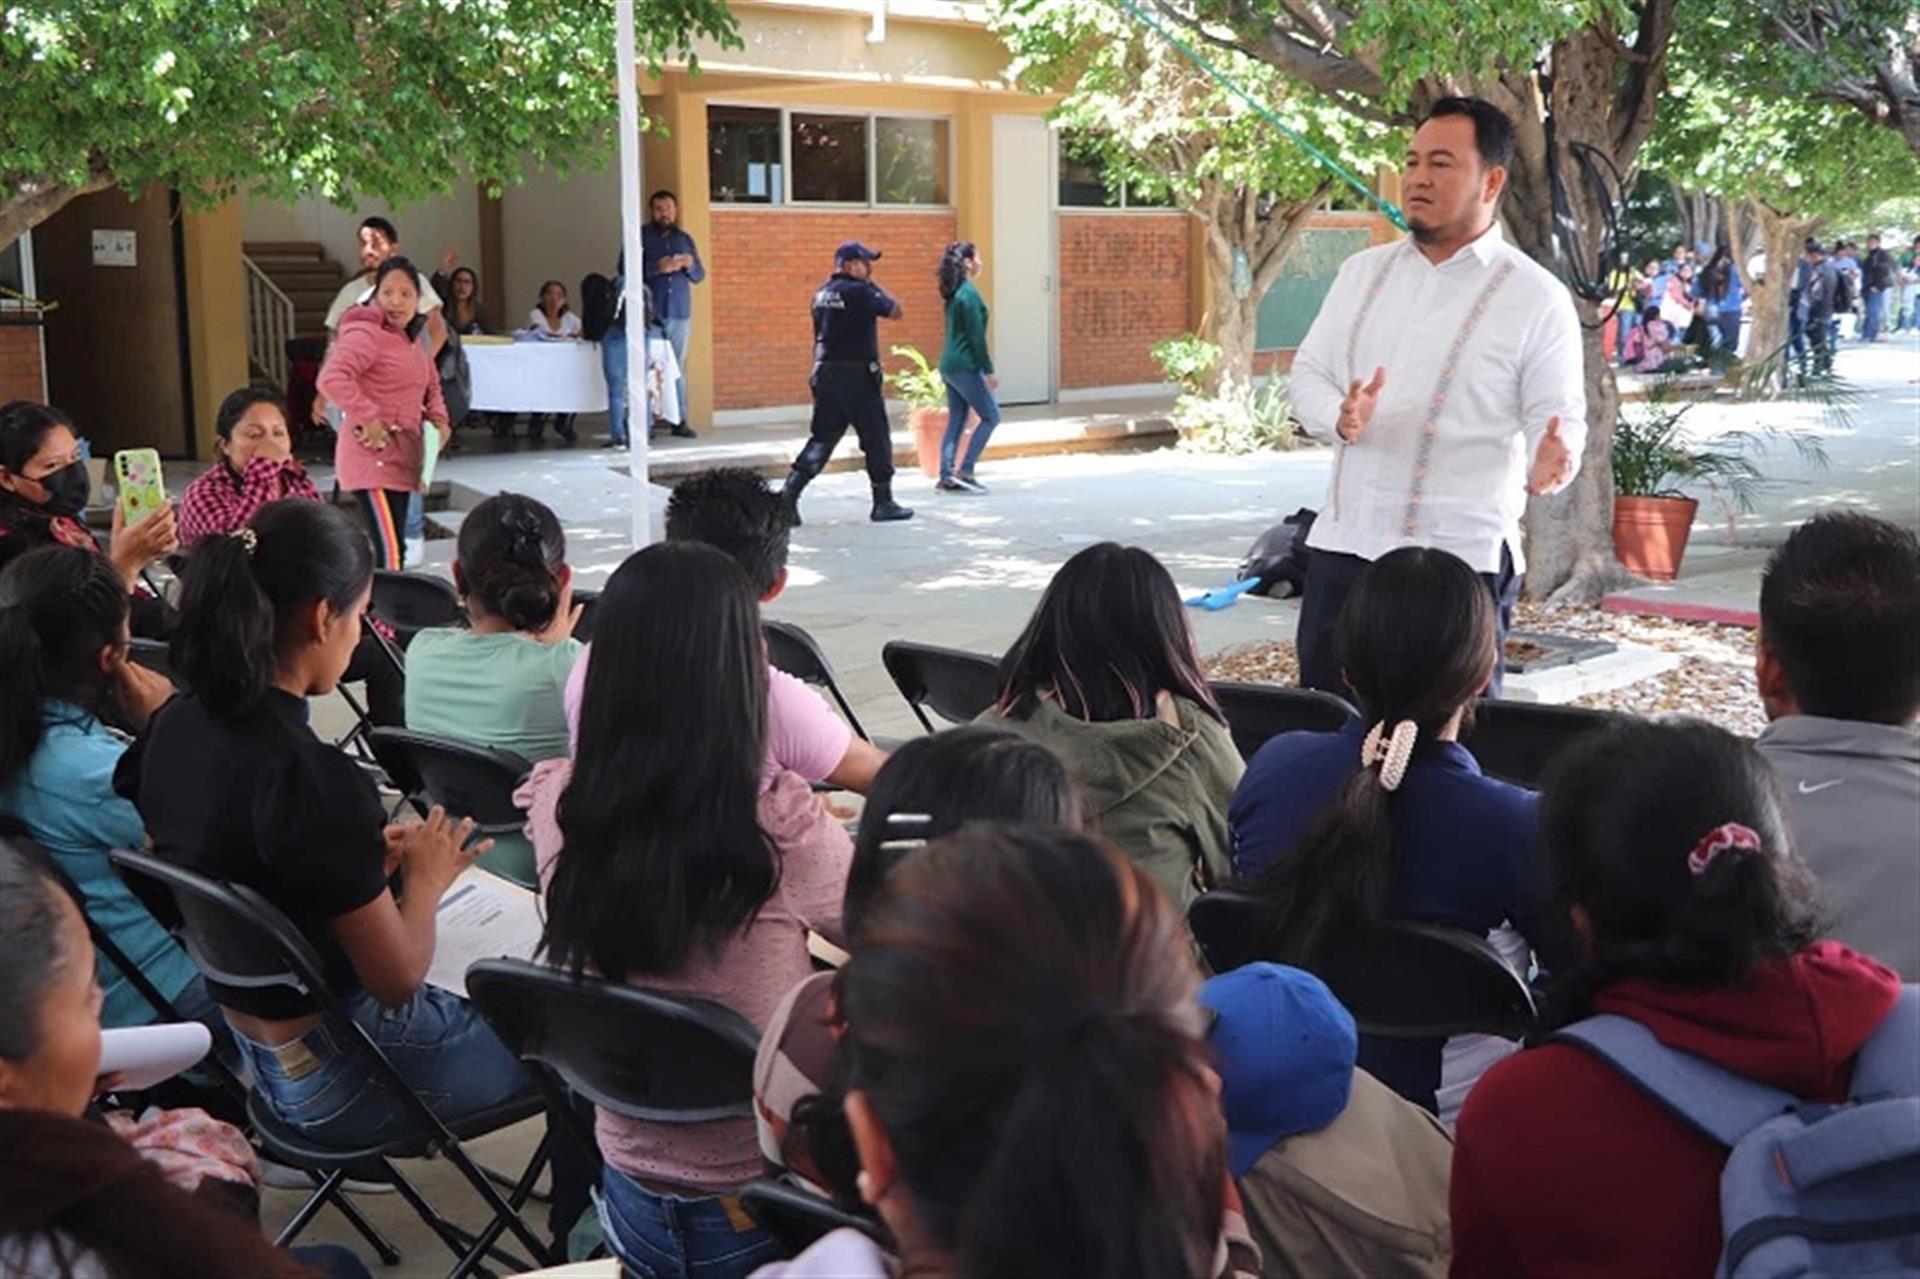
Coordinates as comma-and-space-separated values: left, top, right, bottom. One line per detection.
781, 240, 914, 524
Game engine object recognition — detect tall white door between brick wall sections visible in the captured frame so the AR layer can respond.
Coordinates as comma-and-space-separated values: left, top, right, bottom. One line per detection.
987, 115, 1054, 403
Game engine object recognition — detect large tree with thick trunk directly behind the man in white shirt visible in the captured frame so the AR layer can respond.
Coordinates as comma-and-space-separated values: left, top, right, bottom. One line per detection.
1139, 0, 1678, 601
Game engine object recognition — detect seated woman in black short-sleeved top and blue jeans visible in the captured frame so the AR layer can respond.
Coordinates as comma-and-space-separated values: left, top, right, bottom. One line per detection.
115, 501, 532, 1145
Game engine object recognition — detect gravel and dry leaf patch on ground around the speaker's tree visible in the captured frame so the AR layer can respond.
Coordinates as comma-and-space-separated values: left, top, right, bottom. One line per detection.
1206, 603, 1766, 737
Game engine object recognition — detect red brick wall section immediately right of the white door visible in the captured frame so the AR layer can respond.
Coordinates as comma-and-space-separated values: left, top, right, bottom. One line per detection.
1060, 213, 1192, 390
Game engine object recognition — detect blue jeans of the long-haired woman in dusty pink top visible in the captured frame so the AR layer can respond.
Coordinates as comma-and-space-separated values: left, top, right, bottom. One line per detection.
597, 1166, 780, 1279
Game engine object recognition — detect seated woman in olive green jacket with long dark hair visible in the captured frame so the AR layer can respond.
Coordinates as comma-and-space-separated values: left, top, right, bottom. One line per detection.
983, 542, 1240, 908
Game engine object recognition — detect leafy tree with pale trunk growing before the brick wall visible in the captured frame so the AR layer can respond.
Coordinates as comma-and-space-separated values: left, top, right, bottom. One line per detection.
993, 0, 1392, 405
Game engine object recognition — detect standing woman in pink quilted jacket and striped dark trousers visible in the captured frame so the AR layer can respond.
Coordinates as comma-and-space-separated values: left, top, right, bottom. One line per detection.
319, 257, 453, 568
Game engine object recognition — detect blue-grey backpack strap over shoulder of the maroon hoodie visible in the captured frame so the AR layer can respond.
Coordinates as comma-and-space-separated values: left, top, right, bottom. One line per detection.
1551, 1014, 1799, 1148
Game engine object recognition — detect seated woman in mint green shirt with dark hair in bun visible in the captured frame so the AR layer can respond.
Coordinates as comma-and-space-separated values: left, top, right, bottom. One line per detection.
407, 494, 584, 887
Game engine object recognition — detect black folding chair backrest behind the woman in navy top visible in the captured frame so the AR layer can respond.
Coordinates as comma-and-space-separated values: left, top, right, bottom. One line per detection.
1187, 889, 1534, 1039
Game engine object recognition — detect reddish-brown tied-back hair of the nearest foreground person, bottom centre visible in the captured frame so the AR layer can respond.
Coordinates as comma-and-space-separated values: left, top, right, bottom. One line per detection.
839, 828, 1227, 1279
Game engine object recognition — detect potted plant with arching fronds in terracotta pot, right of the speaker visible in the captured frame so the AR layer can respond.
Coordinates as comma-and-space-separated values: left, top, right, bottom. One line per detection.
1613, 376, 1851, 582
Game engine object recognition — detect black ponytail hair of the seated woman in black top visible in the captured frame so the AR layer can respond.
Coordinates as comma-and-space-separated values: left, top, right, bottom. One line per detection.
169, 497, 372, 720
